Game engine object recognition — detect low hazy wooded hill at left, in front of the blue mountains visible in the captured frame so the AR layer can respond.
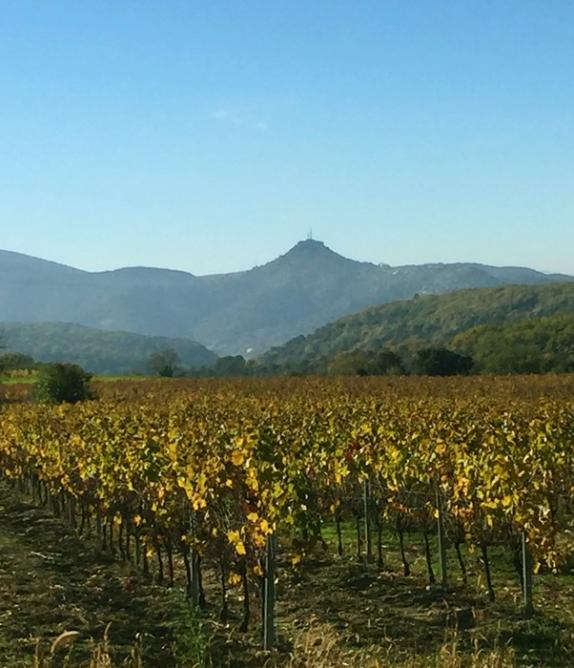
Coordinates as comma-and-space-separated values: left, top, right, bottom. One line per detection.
0, 323, 217, 374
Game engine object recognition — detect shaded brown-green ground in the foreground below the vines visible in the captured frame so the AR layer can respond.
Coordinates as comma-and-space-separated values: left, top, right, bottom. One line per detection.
0, 484, 574, 668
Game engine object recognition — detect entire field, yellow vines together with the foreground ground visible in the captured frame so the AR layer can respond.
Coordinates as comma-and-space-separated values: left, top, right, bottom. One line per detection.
0, 375, 574, 667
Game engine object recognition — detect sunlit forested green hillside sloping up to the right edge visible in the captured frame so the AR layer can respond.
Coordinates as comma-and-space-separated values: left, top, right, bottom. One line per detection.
258, 283, 574, 372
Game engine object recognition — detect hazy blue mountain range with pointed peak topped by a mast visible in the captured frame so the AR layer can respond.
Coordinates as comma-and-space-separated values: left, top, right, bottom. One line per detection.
0, 240, 574, 356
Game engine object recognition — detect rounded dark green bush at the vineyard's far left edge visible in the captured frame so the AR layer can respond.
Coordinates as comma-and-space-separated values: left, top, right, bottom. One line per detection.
36, 363, 94, 404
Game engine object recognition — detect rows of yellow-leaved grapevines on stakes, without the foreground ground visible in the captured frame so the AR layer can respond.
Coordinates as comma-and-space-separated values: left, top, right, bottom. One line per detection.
0, 376, 574, 665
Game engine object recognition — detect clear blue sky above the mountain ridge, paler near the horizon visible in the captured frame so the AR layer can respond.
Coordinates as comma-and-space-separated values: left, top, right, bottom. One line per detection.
0, 0, 574, 274
